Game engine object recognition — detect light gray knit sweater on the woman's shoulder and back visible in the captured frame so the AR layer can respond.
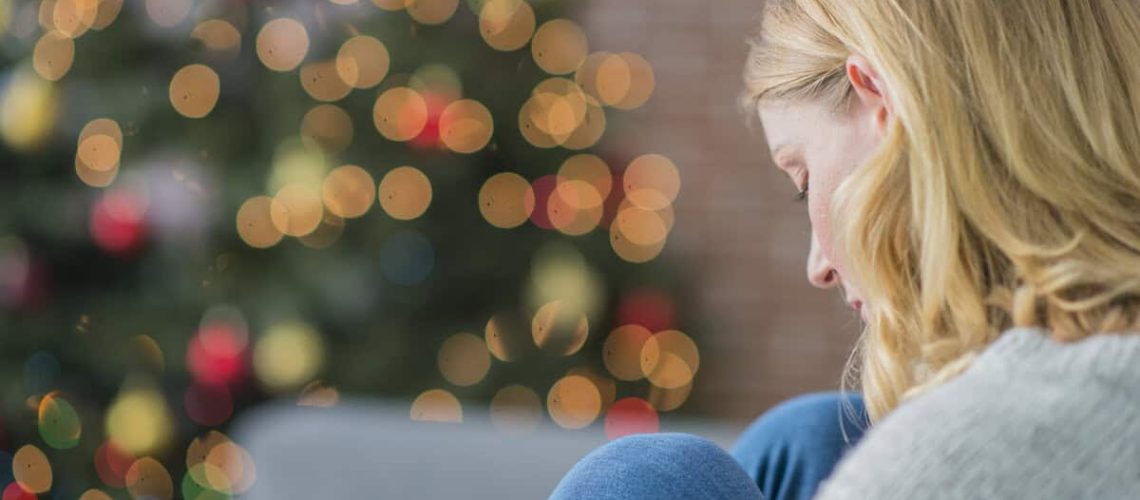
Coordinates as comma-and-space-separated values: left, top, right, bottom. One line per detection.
815, 328, 1140, 500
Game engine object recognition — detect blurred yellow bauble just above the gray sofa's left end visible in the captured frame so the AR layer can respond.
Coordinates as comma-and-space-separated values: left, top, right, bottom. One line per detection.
253, 321, 325, 392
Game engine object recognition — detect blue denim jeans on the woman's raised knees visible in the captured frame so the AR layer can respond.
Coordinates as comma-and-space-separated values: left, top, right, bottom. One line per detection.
551, 392, 868, 500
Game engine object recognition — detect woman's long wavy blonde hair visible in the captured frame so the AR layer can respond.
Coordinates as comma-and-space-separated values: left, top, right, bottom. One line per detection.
743, 0, 1140, 421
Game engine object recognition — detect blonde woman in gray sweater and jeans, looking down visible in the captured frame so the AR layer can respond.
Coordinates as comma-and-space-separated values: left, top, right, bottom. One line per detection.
554, 0, 1140, 499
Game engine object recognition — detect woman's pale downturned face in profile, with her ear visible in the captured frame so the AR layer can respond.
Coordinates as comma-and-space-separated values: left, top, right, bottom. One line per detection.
759, 95, 881, 320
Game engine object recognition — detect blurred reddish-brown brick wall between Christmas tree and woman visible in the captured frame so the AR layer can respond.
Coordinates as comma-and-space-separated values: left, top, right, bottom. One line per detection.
578, 0, 858, 420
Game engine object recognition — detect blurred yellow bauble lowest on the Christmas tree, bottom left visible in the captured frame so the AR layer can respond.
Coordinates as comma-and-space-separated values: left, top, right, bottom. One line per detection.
106, 388, 173, 456
